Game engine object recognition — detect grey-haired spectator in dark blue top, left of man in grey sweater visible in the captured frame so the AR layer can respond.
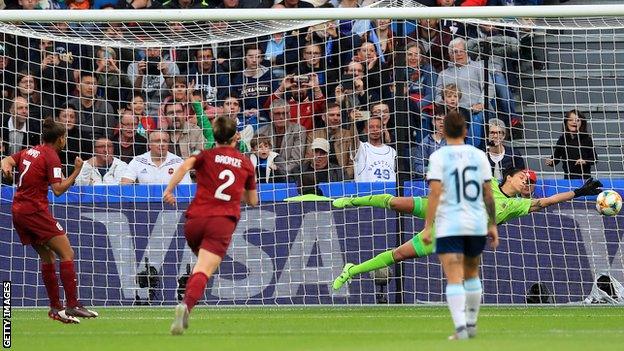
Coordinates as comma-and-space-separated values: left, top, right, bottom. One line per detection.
406, 42, 438, 113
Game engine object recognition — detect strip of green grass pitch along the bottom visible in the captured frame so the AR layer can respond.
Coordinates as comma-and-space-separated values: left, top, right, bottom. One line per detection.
12, 306, 624, 351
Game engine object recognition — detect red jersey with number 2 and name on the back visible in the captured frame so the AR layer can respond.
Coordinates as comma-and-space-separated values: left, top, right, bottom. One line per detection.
186, 146, 256, 220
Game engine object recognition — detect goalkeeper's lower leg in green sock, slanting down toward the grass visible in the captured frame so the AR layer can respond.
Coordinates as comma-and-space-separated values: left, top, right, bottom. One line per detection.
332, 233, 433, 290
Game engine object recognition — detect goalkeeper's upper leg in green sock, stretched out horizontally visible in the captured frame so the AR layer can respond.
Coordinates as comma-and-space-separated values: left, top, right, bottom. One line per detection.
332, 194, 427, 218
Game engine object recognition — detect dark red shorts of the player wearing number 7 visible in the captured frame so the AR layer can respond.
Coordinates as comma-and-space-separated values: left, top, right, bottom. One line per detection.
13, 211, 65, 245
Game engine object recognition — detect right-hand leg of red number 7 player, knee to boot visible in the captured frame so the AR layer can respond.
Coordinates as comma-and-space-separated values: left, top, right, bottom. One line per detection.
46, 235, 98, 318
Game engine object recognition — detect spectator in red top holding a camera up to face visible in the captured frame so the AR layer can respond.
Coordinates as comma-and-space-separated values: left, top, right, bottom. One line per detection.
265, 73, 325, 132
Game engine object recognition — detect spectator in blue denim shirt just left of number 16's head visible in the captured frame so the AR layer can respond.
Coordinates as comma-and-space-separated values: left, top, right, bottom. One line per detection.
410, 107, 446, 179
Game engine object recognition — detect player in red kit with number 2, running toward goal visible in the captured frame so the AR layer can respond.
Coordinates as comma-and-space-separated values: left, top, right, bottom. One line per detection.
163, 117, 258, 335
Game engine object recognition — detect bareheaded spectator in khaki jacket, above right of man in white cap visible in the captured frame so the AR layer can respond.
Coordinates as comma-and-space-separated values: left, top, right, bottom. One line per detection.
306, 103, 356, 179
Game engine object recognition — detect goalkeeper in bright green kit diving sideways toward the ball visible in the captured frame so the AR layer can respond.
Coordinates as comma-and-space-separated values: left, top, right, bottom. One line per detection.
333, 168, 602, 290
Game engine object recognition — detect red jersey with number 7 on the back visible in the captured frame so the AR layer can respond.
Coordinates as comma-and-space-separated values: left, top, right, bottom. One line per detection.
11, 145, 63, 214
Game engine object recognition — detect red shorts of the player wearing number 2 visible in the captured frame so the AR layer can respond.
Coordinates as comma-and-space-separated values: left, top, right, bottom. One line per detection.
184, 217, 237, 258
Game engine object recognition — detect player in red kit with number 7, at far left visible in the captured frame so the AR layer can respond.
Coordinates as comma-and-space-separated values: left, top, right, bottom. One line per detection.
2, 118, 98, 323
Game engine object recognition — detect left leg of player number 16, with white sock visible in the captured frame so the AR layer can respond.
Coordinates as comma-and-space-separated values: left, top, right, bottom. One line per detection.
436, 236, 468, 339
